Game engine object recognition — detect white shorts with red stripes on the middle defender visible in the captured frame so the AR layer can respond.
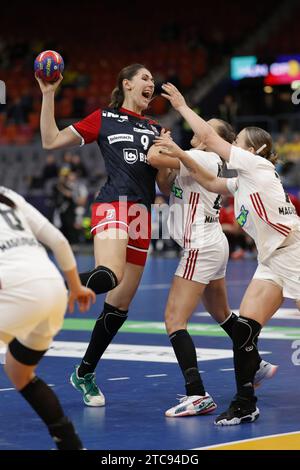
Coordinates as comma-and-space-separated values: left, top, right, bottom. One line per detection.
175, 235, 229, 284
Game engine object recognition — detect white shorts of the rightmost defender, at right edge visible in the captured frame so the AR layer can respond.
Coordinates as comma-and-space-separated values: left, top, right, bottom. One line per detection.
253, 235, 300, 300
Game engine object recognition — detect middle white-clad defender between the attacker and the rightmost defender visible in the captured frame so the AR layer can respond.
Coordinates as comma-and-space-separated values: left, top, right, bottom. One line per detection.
148, 119, 275, 417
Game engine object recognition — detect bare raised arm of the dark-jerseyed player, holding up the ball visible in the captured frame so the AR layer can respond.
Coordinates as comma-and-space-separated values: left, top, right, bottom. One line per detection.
35, 75, 81, 150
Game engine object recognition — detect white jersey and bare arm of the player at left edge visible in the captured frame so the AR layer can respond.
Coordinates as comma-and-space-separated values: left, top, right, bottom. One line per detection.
0, 187, 75, 288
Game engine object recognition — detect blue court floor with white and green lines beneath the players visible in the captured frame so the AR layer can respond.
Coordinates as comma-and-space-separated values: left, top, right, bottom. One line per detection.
0, 256, 300, 450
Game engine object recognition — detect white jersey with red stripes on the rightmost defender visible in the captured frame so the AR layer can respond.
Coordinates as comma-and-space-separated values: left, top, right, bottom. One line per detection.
227, 146, 300, 262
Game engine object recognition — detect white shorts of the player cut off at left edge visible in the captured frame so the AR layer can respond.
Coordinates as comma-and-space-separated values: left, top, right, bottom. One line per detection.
0, 277, 68, 351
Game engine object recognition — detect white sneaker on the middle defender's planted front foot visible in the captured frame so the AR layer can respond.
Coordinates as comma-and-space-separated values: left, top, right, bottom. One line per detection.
165, 393, 217, 418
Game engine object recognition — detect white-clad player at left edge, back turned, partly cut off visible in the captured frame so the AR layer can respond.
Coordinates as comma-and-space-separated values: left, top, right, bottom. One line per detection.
0, 187, 95, 450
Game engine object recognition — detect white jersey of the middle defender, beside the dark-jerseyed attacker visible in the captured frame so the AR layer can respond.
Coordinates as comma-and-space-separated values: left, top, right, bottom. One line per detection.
168, 149, 224, 249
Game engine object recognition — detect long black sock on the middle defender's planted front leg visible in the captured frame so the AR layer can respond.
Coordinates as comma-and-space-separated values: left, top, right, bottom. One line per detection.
169, 330, 205, 396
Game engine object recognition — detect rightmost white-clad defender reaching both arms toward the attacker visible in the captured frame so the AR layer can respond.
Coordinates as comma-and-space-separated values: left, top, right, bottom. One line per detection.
157, 84, 300, 425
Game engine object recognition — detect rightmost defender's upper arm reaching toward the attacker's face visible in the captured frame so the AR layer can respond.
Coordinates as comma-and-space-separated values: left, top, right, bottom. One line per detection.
162, 83, 231, 163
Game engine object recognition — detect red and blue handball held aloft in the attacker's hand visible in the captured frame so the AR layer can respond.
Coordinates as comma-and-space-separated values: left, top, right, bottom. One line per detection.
34, 51, 64, 82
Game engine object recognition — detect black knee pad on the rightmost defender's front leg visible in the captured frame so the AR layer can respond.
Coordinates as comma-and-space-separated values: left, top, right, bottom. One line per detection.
232, 316, 261, 352
